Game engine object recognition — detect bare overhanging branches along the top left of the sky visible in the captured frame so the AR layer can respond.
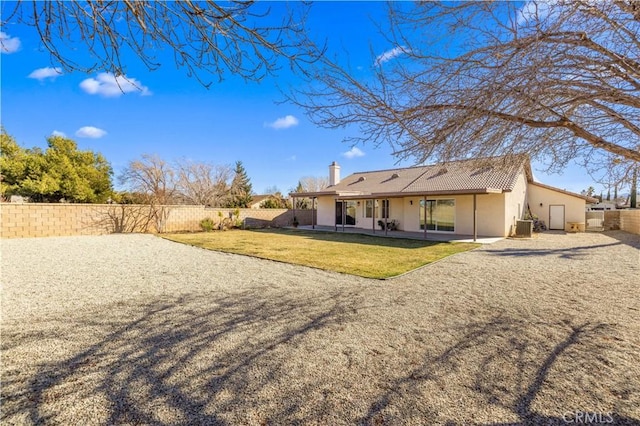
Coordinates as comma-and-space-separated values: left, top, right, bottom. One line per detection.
2, 0, 321, 85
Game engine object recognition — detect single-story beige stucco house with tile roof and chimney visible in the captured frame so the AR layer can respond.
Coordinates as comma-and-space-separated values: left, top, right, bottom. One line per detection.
291, 155, 593, 237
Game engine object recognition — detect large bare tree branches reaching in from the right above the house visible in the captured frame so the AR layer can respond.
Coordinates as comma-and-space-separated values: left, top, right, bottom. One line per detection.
291, 0, 640, 182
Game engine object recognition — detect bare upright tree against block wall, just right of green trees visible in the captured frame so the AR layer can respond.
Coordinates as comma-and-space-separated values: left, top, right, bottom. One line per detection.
120, 154, 178, 232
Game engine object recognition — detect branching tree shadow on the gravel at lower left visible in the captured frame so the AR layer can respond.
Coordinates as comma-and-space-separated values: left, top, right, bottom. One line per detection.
2, 291, 360, 425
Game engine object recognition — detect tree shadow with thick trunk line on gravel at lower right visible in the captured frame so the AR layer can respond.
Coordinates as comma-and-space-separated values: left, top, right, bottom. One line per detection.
359, 316, 640, 426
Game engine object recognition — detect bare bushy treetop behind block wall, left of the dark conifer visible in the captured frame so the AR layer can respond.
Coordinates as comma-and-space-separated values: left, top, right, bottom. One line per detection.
176, 160, 231, 207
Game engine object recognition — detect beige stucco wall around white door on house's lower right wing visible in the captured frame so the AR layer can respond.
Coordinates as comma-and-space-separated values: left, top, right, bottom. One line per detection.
528, 184, 586, 231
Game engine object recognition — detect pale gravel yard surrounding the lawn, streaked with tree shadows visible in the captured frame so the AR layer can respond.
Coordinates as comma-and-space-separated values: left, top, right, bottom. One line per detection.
0, 231, 640, 425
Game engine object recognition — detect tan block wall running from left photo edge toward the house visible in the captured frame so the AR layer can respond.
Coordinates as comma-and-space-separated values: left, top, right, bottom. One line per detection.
0, 203, 315, 238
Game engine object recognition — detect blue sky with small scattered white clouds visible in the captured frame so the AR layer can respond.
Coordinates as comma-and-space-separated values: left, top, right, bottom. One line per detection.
0, 2, 601, 193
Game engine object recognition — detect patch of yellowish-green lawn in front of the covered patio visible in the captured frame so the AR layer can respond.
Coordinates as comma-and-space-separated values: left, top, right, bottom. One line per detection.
163, 229, 479, 278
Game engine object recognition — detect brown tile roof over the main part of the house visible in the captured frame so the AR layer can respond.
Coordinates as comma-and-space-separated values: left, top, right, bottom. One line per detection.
304, 155, 531, 196
